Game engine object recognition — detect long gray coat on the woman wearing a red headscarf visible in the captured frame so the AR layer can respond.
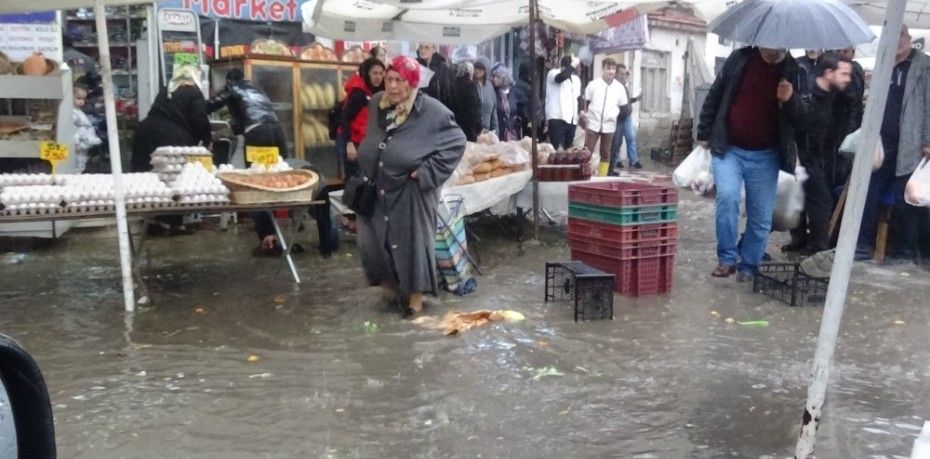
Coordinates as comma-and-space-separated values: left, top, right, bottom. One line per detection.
356, 93, 465, 296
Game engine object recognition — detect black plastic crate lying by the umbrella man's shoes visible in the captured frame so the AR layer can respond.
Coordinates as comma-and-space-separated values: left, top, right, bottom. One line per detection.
752, 263, 830, 306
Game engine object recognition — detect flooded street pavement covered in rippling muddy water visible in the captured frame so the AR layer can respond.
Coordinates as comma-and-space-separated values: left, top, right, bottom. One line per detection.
0, 193, 930, 458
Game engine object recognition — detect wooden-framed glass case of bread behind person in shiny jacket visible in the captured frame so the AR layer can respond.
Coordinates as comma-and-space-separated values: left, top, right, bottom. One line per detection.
210, 54, 358, 183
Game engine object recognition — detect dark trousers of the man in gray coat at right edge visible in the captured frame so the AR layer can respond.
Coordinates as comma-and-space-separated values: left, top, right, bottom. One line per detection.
857, 164, 923, 259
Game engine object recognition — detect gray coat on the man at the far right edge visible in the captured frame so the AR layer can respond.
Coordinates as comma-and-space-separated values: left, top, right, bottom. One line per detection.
895, 51, 930, 176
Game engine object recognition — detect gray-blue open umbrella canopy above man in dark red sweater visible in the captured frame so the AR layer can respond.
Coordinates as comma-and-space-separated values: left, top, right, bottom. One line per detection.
710, 0, 875, 49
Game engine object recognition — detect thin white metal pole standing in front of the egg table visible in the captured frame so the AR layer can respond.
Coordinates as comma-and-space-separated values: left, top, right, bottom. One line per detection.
94, 0, 136, 312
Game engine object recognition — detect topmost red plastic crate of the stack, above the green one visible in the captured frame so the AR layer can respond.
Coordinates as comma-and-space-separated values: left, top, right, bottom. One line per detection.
568, 182, 678, 207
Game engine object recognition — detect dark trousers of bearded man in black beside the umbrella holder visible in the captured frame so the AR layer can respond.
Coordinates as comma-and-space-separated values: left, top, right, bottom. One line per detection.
791, 157, 834, 252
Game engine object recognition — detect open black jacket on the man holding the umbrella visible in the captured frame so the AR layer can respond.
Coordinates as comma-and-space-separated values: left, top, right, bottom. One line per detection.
697, 47, 808, 174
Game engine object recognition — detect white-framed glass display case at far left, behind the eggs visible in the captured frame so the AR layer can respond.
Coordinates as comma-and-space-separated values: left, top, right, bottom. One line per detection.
0, 68, 76, 238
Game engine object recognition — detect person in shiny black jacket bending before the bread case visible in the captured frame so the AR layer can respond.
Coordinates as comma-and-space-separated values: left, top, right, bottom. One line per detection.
208, 69, 290, 255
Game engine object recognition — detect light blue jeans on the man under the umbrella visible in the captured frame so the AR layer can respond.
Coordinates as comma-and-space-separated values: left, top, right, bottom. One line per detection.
712, 146, 779, 275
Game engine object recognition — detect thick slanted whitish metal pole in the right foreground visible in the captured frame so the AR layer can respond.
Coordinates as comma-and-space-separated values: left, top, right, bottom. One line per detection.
794, 0, 907, 459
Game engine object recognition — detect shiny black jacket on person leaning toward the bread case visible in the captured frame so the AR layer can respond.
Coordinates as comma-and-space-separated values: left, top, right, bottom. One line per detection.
208, 80, 278, 134
